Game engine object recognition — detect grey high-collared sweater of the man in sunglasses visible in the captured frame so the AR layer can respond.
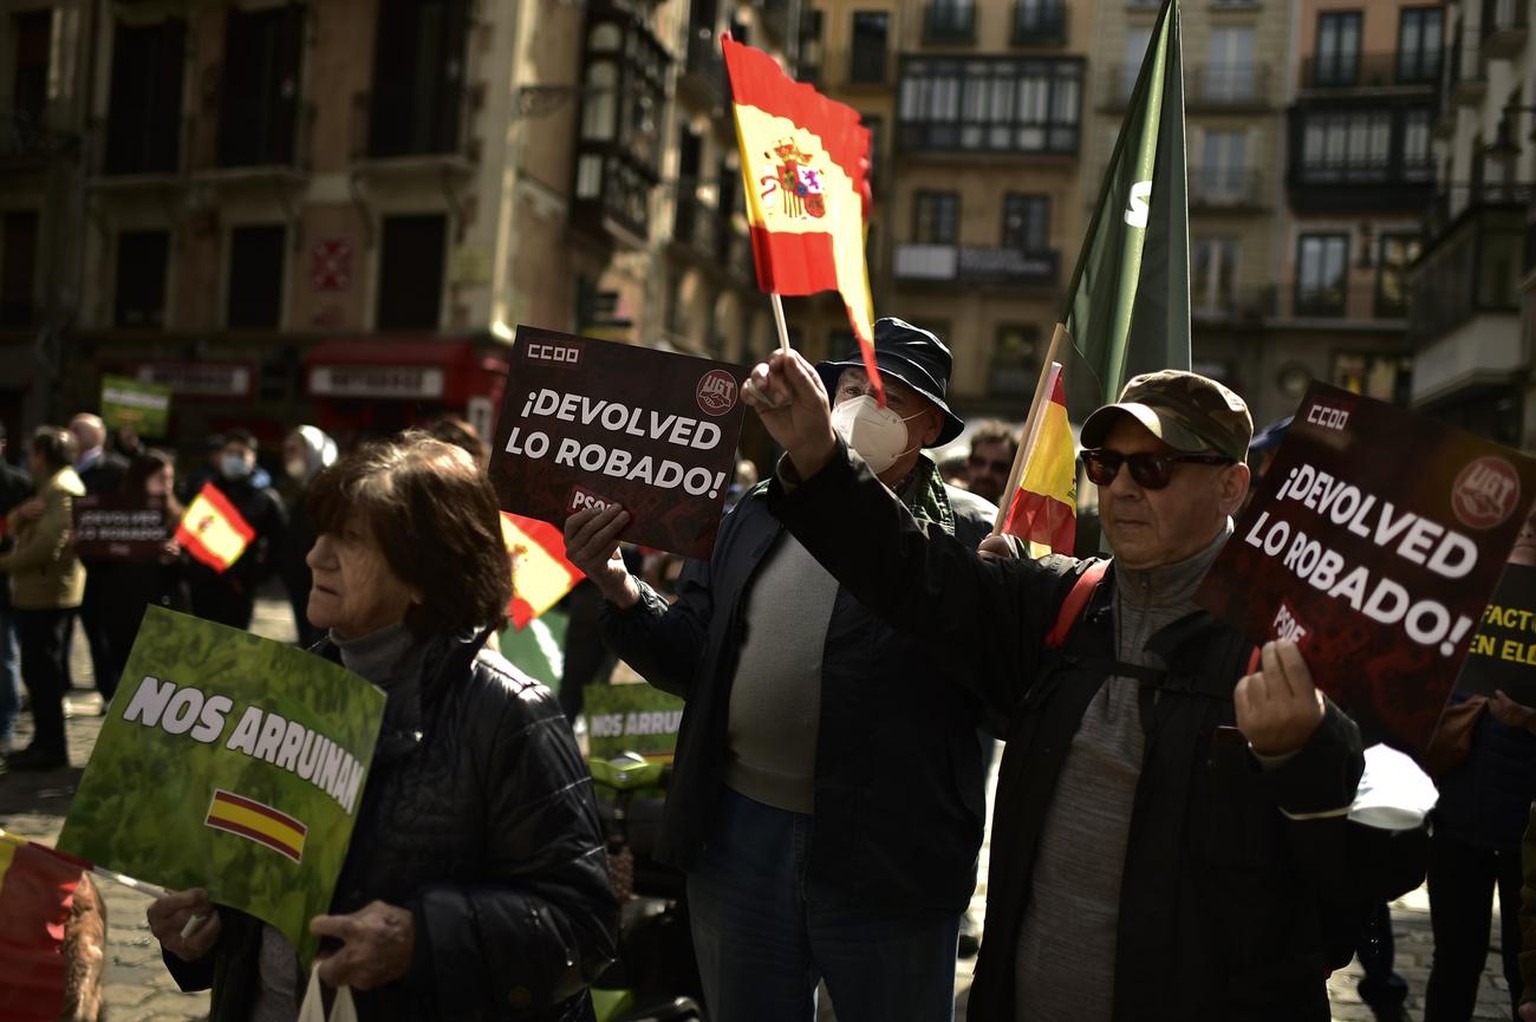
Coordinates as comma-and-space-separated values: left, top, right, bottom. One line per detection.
1014, 519, 1232, 1022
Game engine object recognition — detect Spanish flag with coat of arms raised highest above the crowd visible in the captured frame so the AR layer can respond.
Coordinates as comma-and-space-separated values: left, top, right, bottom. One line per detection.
720, 35, 885, 404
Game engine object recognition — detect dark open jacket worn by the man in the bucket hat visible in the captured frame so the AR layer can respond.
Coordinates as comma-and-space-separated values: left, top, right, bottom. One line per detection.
604, 460, 994, 913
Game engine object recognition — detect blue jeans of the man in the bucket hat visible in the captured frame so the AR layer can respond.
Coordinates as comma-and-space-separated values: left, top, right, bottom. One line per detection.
688, 788, 960, 1022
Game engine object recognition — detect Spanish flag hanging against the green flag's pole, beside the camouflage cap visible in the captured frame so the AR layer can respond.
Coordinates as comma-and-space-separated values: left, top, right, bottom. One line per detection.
1003, 364, 1077, 558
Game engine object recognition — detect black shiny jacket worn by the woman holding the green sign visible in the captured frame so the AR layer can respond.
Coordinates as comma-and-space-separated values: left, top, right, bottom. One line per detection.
164, 638, 617, 1022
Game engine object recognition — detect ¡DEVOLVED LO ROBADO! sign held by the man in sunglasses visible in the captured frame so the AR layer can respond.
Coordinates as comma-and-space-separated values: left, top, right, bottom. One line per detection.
1197, 383, 1536, 750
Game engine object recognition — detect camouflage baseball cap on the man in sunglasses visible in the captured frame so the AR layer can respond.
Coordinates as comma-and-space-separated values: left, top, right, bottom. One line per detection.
1083, 369, 1253, 461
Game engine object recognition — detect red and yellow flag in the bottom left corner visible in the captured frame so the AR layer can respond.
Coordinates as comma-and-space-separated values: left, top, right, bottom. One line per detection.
0, 833, 84, 1022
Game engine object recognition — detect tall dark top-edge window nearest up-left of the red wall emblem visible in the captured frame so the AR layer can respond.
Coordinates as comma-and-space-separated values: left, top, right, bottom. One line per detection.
218, 5, 304, 168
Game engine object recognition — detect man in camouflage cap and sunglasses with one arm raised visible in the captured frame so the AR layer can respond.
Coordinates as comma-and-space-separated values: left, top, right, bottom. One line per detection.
743, 353, 1413, 1022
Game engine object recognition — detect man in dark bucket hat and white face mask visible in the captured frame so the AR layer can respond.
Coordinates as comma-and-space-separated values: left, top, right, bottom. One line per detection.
565, 318, 995, 1022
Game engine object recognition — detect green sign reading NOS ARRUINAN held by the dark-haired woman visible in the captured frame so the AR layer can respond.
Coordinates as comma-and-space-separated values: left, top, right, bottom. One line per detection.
58, 606, 384, 967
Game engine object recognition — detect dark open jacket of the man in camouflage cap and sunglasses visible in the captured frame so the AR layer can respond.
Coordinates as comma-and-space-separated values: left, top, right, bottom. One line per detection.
770, 455, 1419, 1022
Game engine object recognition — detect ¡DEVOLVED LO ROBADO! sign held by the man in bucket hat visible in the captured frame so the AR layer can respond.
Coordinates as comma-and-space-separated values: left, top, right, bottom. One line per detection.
490, 326, 746, 558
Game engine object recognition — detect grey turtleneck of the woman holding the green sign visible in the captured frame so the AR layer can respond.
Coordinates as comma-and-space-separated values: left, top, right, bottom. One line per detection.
250, 624, 427, 1022
